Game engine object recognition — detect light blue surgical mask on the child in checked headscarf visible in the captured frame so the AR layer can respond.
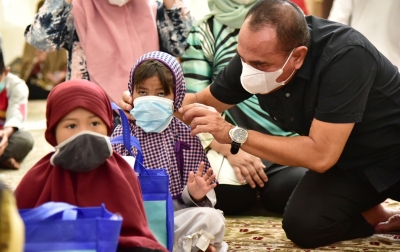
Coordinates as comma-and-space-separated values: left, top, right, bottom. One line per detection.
130, 96, 174, 133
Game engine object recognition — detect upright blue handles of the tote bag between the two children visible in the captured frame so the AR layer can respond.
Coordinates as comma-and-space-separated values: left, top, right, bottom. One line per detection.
110, 102, 148, 174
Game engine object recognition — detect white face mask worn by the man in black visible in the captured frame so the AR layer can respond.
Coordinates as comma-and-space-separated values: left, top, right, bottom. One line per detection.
240, 49, 296, 94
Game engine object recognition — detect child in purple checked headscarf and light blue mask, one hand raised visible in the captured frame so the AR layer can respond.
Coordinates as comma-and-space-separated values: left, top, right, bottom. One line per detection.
112, 52, 228, 252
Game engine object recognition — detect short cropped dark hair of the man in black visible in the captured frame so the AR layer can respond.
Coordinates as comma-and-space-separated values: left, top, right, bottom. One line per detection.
246, 0, 310, 54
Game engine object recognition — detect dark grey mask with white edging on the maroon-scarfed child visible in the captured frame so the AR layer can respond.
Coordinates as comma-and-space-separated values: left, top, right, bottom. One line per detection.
50, 131, 113, 172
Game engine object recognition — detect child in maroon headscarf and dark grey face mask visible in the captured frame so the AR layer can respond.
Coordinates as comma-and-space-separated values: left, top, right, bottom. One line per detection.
15, 80, 167, 251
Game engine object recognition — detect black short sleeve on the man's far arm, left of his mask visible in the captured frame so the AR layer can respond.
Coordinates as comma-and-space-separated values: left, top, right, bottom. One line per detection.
210, 54, 252, 104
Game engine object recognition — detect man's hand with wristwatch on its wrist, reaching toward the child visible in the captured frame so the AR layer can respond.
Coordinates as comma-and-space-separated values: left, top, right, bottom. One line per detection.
179, 103, 234, 144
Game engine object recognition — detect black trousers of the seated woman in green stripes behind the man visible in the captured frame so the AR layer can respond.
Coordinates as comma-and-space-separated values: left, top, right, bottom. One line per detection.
214, 167, 307, 215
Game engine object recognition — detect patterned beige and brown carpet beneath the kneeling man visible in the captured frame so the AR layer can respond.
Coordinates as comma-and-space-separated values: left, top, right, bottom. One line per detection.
225, 200, 400, 252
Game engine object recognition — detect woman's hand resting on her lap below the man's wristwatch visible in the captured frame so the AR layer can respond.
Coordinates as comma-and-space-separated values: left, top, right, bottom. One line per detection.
226, 150, 268, 188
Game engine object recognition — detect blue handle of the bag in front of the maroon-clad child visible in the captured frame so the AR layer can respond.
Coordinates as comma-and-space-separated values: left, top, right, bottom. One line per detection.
20, 202, 86, 222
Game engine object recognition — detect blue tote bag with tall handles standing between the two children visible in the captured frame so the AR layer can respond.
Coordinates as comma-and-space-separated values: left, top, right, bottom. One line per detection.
111, 103, 174, 251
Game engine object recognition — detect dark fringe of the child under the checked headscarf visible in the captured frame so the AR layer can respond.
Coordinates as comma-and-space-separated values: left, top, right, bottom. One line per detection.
133, 59, 175, 95
